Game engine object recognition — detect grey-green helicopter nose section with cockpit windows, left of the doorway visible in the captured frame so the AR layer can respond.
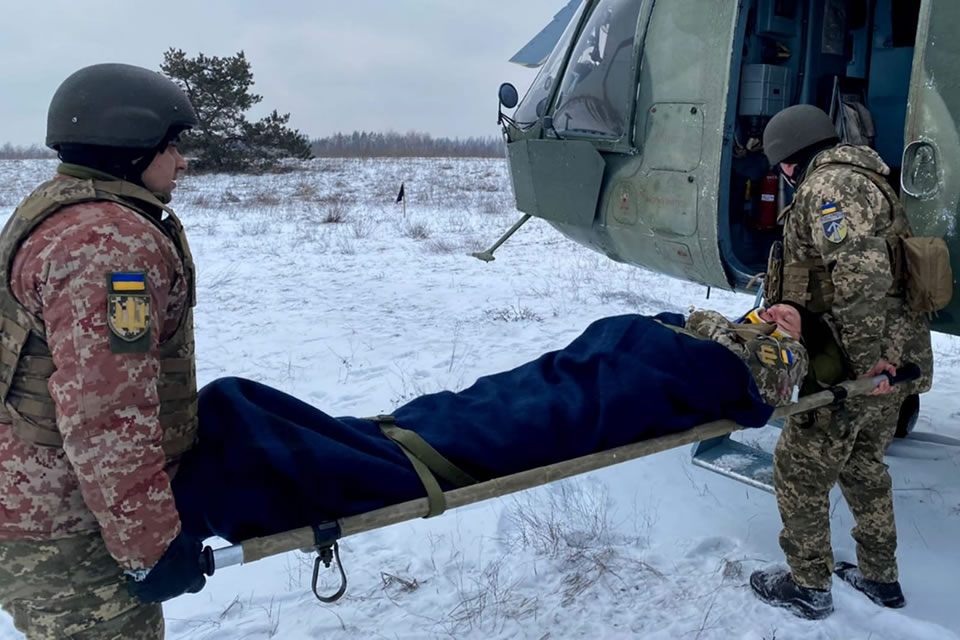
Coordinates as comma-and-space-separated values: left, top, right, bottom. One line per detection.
506, 0, 738, 288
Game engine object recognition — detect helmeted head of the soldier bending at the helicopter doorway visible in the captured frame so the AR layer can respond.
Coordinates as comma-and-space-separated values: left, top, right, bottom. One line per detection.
763, 104, 840, 186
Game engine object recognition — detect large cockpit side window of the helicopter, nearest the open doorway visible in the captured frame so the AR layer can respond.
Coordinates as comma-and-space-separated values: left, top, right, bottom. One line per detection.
553, 0, 642, 139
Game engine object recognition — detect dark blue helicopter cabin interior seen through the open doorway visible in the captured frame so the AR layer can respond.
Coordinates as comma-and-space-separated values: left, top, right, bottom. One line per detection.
719, 0, 921, 273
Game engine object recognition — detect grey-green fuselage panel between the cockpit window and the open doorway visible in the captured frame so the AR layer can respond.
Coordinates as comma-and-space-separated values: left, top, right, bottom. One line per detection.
600, 0, 742, 289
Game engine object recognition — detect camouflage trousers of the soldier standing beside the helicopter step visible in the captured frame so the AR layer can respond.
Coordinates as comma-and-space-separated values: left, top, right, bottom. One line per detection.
773, 392, 903, 589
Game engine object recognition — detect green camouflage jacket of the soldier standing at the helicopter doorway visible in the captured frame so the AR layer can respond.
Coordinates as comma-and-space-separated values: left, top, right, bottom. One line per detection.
783, 145, 933, 390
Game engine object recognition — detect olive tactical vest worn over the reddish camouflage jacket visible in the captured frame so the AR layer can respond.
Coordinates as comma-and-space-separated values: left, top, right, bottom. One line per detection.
0, 177, 197, 461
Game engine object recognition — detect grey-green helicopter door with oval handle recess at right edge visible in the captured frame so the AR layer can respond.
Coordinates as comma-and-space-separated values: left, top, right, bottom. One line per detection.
900, 0, 960, 335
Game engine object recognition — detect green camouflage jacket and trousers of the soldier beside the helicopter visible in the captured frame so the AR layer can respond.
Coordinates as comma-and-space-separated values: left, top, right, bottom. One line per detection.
768, 145, 933, 589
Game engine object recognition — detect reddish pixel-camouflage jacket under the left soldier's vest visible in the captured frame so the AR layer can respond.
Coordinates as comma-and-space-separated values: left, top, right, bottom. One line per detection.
0, 171, 192, 569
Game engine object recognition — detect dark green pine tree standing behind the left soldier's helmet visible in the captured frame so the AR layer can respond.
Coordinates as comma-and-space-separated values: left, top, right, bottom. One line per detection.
160, 48, 310, 172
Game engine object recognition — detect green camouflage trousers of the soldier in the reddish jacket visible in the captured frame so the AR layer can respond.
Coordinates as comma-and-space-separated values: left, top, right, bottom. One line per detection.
0, 533, 163, 640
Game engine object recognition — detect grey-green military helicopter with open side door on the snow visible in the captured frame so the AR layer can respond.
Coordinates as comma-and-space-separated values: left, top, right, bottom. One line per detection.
484, 0, 960, 480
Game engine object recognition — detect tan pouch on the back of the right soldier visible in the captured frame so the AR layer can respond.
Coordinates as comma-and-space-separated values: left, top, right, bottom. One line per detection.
900, 237, 953, 313
